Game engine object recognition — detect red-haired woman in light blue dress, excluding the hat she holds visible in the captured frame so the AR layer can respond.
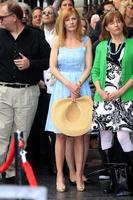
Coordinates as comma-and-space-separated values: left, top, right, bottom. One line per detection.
45, 8, 92, 192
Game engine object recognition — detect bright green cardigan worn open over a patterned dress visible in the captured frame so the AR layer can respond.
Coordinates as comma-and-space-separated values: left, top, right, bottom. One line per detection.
91, 39, 133, 102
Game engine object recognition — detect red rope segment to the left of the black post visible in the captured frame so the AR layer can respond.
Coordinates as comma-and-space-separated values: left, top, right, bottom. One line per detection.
0, 139, 15, 173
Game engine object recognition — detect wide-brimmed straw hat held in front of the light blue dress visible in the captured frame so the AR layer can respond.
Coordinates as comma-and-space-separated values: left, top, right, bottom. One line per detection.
51, 96, 93, 137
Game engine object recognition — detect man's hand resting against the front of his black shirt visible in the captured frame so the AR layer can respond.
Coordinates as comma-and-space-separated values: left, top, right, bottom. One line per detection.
14, 53, 30, 70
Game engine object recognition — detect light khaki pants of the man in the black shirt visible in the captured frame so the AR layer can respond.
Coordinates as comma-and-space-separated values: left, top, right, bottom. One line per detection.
0, 86, 40, 178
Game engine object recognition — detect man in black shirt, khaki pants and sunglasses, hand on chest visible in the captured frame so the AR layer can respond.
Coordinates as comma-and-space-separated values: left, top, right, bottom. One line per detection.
0, 1, 50, 183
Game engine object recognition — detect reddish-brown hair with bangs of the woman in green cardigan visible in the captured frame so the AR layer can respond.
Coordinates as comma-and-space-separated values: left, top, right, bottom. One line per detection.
99, 11, 127, 40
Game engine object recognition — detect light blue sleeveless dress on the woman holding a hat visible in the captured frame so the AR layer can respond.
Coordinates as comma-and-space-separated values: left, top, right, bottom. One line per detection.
45, 42, 91, 133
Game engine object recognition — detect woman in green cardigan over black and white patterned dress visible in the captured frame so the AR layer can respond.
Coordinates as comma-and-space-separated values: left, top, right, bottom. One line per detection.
92, 11, 133, 164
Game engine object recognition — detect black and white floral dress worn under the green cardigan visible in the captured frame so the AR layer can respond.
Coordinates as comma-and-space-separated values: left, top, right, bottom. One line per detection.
93, 41, 133, 132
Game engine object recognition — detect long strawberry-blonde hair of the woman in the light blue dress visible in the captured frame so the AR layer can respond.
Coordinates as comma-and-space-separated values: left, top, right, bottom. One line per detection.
56, 8, 82, 46
